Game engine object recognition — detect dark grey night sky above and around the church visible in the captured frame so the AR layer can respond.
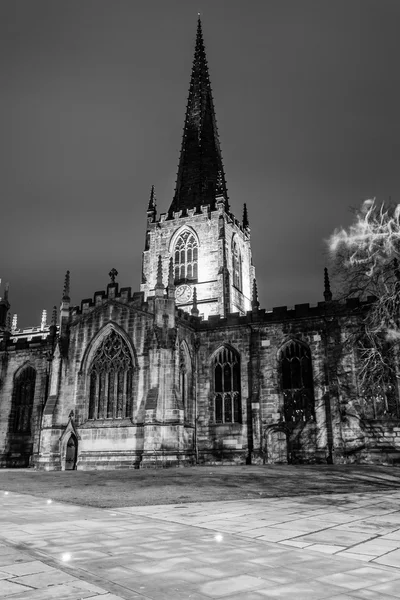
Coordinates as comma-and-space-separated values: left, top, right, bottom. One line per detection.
0, 0, 400, 326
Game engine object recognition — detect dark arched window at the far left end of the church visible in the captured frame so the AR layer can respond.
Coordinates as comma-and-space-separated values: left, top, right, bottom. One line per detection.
12, 367, 36, 434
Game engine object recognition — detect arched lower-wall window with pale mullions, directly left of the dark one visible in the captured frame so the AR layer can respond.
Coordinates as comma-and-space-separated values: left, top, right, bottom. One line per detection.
213, 347, 242, 423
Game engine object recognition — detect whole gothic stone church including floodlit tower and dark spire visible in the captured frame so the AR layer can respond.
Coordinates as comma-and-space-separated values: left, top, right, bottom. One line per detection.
0, 19, 400, 470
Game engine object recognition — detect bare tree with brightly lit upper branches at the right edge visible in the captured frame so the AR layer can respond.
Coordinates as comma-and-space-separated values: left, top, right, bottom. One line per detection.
328, 200, 400, 414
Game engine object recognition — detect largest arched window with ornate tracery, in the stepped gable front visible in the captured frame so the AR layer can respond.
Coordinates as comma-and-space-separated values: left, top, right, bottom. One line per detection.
88, 330, 133, 419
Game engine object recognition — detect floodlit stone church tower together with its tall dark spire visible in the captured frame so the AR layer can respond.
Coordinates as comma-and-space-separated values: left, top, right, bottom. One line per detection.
141, 18, 255, 318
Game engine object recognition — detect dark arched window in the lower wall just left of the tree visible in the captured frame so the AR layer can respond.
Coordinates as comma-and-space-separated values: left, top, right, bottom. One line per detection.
280, 340, 314, 423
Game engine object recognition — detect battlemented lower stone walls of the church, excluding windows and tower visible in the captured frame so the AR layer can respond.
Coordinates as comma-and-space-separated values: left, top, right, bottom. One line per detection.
0, 290, 400, 469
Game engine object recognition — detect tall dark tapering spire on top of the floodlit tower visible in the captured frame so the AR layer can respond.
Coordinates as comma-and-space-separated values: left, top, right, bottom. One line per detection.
169, 16, 229, 216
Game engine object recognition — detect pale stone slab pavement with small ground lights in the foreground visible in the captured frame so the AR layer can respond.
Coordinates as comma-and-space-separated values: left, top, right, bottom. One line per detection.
0, 491, 400, 600
